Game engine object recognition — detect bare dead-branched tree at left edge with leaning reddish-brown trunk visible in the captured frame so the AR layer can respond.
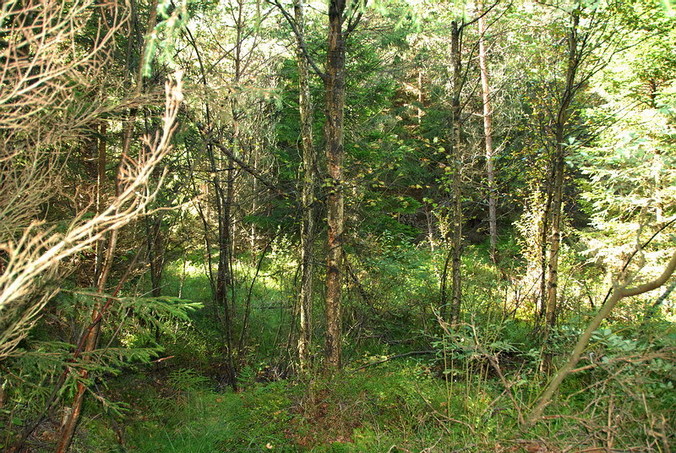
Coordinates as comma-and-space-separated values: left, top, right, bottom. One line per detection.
0, 0, 189, 451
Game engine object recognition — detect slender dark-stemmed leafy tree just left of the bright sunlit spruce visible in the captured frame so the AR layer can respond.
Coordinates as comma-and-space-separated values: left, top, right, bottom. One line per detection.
510, 2, 625, 352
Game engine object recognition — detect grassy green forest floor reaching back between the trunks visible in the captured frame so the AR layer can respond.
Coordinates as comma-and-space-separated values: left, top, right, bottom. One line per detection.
67, 247, 673, 453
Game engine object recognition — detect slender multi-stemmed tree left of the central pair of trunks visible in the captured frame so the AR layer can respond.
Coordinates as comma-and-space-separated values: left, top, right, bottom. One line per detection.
179, 0, 284, 388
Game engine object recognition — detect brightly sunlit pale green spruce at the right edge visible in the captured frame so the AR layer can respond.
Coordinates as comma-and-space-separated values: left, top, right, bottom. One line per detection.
573, 3, 676, 273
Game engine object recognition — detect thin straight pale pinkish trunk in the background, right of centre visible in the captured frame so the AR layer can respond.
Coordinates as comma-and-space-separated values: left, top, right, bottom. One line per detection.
478, 8, 498, 263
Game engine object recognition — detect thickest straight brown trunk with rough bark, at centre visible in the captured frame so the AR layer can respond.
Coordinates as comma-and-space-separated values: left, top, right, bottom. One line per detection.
324, 0, 345, 370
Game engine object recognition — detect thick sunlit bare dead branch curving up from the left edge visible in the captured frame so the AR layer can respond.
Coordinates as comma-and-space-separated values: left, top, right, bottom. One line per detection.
0, 71, 182, 360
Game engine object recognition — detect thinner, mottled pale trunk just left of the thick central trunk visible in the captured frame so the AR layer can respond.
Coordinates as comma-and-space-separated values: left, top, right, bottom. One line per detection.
294, 0, 317, 371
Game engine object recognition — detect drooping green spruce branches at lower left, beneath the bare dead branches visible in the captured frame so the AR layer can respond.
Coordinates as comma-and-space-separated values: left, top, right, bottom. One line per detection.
0, 286, 200, 448
